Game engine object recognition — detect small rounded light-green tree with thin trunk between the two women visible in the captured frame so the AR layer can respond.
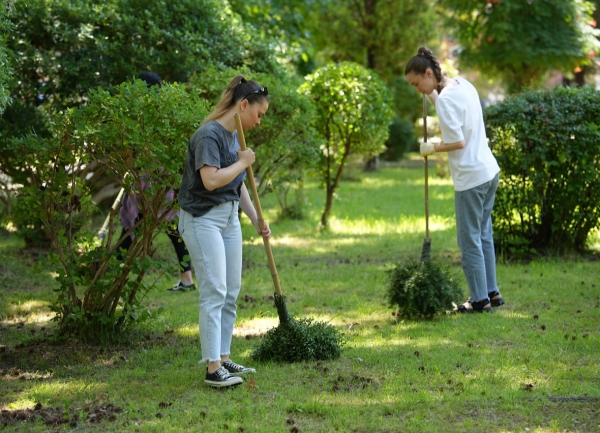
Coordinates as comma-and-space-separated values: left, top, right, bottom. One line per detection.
299, 62, 394, 227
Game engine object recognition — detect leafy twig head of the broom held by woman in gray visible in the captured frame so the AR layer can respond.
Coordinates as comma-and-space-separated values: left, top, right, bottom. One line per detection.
252, 317, 345, 363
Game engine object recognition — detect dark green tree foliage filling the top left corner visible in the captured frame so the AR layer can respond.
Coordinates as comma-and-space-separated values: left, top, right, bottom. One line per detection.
0, 0, 277, 216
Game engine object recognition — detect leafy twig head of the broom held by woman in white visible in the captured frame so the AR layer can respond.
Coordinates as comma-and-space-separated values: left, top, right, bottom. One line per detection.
387, 260, 463, 319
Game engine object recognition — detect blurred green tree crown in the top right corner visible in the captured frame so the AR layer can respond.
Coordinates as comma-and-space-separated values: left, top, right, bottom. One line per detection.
438, 0, 599, 92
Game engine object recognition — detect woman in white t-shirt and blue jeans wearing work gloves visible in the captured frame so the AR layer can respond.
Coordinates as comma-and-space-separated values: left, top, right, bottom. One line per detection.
404, 47, 504, 313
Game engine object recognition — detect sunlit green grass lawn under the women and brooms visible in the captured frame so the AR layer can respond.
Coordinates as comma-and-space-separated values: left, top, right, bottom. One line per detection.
0, 164, 600, 433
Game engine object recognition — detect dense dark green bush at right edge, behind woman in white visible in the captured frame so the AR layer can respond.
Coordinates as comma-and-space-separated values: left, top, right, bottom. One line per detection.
485, 87, 600, 255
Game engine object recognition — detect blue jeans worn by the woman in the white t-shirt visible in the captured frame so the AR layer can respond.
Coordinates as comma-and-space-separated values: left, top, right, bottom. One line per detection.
458, 174, 499, 301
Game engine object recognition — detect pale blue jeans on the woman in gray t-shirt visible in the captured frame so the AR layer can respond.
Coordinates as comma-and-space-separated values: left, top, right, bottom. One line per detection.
179, 201, 242, 362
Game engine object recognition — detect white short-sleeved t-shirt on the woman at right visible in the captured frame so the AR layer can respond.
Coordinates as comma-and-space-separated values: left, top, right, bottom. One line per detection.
435, 78, 500, 191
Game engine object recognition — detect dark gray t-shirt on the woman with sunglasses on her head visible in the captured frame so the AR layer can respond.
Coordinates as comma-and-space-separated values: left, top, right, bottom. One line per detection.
179, 120, 246, 217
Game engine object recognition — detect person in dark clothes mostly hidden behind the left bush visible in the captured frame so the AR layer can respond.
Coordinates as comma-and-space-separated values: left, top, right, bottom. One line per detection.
117, 72, 196, 292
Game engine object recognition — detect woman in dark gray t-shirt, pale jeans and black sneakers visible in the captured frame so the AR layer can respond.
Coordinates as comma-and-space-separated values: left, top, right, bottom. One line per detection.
179, 75, 271, 387
